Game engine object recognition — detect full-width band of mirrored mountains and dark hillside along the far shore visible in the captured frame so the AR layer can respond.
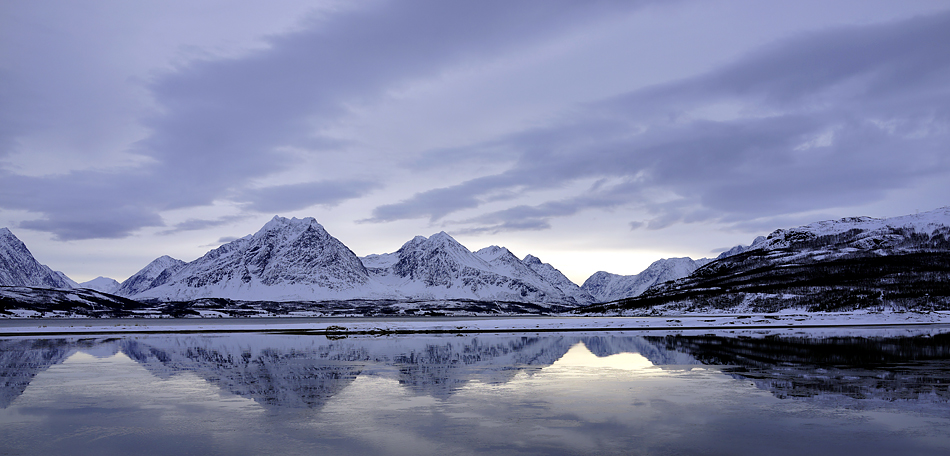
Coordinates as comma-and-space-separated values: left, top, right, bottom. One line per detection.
0, 333, 950, 408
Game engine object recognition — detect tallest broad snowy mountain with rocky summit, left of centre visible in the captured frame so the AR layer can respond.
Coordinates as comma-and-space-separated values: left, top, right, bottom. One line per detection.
132, 216, 369, 301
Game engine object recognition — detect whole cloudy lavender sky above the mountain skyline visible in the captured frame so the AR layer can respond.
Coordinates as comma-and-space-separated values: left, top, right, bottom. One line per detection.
0, 0, 950, 284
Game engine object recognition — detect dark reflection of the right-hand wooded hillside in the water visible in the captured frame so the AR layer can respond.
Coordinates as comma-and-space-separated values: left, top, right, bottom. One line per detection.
646, 333, 950, 402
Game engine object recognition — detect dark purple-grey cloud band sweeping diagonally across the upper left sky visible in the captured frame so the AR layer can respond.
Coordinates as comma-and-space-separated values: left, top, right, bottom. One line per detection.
0, 0, 664, 239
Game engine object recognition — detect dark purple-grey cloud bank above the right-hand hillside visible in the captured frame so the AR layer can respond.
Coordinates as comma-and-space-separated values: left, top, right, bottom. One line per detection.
371, 13, 950, 231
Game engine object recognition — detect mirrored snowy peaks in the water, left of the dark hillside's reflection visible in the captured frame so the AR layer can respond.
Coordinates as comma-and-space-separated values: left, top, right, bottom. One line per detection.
0, 335, 690, 408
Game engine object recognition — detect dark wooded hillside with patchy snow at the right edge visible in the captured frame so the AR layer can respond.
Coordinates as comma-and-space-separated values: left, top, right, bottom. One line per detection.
587, 207, 950, 313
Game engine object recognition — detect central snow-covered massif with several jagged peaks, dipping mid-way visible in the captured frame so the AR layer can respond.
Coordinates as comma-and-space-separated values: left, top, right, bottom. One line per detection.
116, 217, 593, 306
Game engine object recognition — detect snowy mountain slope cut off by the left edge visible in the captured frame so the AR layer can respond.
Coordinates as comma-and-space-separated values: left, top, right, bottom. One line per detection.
0, 228, 76, 288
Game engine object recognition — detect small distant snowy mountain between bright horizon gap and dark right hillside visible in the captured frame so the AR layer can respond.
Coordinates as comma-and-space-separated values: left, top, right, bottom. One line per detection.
581, 257, 711, 302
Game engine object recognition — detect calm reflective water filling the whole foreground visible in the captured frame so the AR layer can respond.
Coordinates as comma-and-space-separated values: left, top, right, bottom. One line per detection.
0, 328, 950, 455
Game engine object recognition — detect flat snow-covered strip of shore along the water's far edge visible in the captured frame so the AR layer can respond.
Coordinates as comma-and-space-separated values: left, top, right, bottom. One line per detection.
0, 312, 950, 335
